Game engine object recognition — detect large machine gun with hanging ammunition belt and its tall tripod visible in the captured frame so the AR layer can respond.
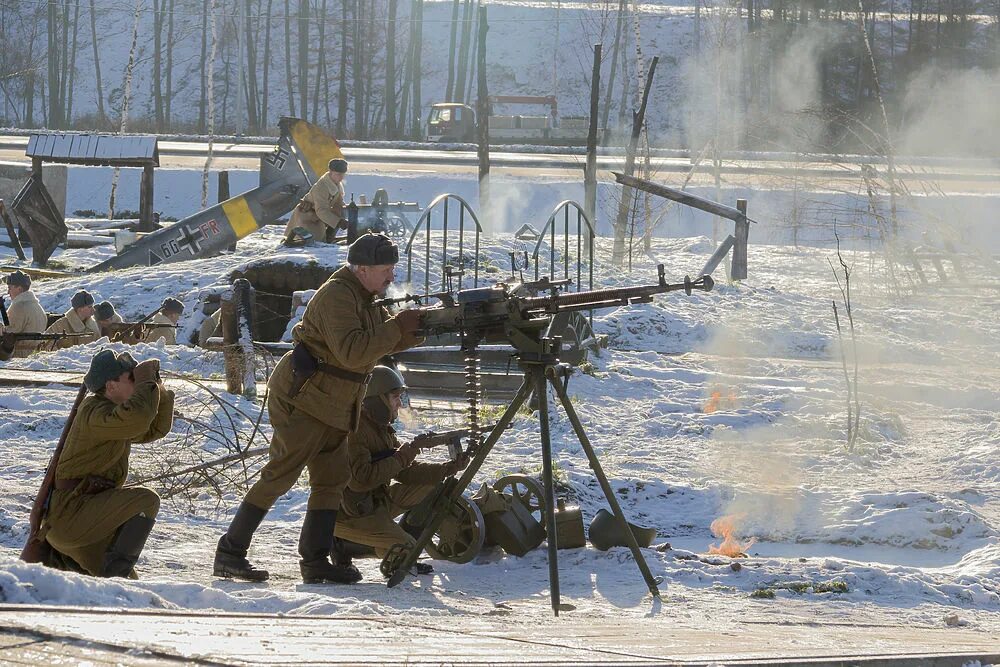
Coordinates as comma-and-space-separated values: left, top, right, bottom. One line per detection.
381, 264, 715, 616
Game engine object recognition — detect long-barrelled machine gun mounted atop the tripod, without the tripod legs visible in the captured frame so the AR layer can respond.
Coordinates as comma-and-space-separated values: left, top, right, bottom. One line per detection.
417, 264, 715, 347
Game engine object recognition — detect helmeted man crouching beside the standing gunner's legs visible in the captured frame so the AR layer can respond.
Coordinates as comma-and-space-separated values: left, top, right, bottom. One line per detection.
334, 366, 469, 574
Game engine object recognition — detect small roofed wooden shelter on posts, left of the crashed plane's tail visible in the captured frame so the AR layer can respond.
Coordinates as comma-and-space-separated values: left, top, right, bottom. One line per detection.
24, 132, 160, 232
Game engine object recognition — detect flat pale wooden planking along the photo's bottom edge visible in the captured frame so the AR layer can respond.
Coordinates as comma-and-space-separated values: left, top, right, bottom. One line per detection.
0, 608, 1000, 667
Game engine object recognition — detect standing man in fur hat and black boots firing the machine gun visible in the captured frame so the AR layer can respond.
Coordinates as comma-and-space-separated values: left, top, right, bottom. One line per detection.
214, 234, 420, 583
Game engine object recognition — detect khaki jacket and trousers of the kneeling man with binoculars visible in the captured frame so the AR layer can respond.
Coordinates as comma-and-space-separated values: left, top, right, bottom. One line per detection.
42, 382, 174, 576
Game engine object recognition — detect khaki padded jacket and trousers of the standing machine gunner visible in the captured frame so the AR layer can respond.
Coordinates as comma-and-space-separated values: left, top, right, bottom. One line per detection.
245, 266, 403, 510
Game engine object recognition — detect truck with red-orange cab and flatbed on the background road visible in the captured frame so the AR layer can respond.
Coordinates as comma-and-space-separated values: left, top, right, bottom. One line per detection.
426, 95, 602, 145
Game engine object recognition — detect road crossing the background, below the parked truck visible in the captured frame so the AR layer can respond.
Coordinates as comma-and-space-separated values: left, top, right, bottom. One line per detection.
0, 136, 1000, 194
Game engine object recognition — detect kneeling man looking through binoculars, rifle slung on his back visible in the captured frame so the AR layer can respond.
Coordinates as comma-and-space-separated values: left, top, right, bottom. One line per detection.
41, 350, 174, 578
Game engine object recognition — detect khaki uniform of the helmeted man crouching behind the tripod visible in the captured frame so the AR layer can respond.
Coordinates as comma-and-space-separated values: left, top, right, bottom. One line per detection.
334, 412, 447, 558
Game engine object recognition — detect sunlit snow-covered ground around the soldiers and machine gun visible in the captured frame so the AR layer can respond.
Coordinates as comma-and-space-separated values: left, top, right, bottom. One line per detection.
0, 168, 1000, 633
